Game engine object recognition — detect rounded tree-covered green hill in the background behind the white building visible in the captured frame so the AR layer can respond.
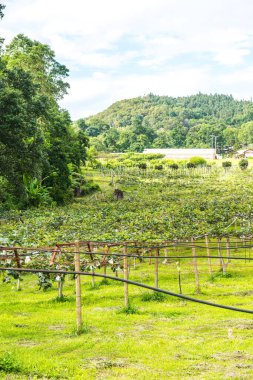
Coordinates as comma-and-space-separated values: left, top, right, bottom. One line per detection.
76, 93, 253, 152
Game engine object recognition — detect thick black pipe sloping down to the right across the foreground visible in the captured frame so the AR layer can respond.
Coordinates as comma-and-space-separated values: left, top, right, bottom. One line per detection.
0, 268, 253, 314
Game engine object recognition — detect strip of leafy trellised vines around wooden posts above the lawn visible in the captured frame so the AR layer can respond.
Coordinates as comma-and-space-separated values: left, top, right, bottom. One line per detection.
0, 235, 253, 299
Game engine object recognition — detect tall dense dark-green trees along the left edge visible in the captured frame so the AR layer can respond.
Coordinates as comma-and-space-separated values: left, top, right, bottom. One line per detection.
0, 4, 88, 207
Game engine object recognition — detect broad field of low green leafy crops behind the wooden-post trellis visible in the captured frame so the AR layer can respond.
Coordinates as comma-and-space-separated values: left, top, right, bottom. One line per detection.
0, 168, 253, 247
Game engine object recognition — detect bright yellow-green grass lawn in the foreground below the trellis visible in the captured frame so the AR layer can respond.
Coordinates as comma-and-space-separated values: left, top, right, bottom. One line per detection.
0, 255, 253, 379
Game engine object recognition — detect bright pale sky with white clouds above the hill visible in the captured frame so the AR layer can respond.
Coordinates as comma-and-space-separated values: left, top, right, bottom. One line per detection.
0, 0, 253, 120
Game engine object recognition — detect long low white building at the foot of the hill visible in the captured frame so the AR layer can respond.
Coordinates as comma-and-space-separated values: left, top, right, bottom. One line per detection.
143, 148, 217, 160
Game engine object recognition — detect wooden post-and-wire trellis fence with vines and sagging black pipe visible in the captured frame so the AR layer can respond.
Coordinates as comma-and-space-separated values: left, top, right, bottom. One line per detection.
0, 235, 253, 330
